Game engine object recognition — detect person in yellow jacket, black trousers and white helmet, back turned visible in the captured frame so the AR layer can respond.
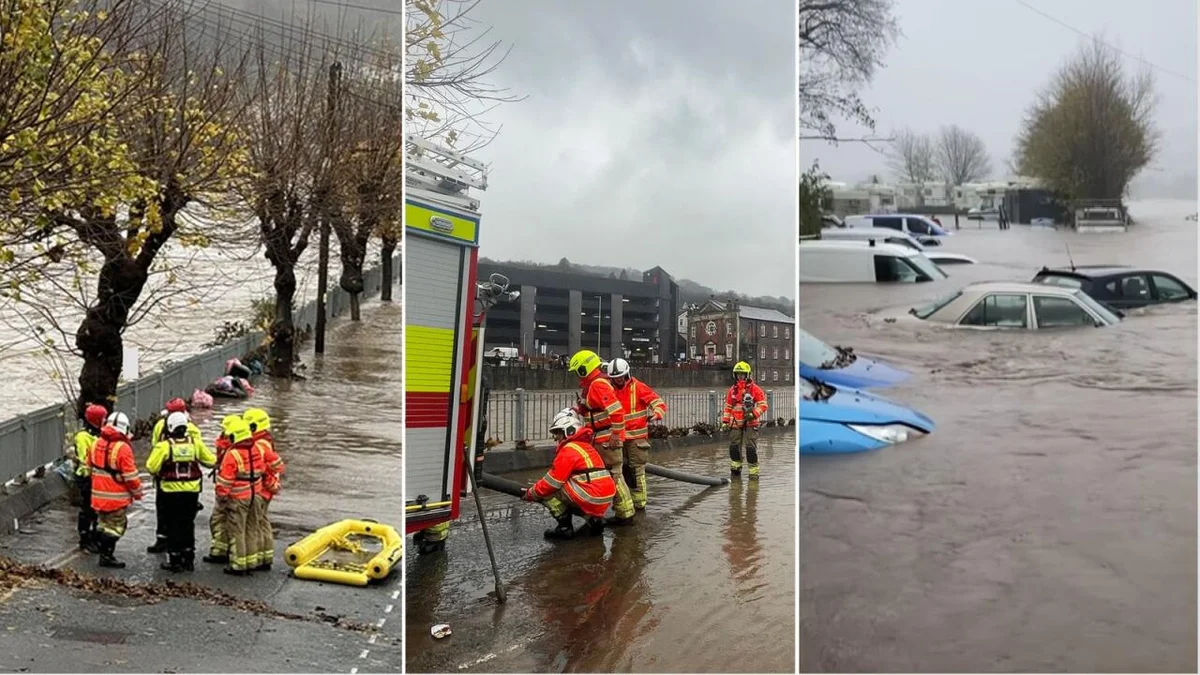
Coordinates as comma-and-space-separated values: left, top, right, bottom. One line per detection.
146, 412, 217, 572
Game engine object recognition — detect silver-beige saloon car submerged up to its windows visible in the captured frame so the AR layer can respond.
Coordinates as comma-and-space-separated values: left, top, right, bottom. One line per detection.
908, 281, 1121, 329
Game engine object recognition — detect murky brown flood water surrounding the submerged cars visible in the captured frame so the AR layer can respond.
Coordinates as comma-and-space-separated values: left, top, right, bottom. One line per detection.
799, 196, 1196, 673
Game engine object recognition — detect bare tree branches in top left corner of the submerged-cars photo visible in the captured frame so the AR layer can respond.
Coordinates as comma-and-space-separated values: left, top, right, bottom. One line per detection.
798, 0, 900, 141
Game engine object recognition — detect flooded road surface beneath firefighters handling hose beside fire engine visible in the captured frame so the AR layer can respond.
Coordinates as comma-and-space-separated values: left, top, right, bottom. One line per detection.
406, 432, 796, 673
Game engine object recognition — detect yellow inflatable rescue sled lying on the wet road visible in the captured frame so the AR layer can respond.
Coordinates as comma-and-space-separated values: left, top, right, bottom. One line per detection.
283, 519, 404, 586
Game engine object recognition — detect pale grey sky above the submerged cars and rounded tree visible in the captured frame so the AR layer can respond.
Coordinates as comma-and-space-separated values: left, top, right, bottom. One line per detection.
800, 0, 1196, 191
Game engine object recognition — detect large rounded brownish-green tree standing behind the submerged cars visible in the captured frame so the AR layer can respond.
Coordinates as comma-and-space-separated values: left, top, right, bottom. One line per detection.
1015, 40, 1160, 199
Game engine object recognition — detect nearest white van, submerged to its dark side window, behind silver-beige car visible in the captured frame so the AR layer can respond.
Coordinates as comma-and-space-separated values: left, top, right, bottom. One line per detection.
799, 240, 947, 283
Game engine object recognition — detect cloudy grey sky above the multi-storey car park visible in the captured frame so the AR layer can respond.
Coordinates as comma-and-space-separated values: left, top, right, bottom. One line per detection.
458, 0, 797, 297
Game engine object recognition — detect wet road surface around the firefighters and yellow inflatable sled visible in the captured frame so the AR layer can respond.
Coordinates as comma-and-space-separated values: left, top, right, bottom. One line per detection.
0, 303, 403, 673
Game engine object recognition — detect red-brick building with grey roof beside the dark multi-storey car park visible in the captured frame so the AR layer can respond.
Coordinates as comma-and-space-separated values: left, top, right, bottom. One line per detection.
688, 300, 796, 384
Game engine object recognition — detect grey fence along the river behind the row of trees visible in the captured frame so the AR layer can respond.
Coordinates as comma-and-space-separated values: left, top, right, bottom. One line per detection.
0, 255, 401, 484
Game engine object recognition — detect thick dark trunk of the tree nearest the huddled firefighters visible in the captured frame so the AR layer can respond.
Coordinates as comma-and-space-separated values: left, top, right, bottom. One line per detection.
76, 256, 148, 411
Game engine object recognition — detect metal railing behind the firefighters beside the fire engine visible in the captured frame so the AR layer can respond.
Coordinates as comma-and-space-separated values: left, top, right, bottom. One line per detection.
487, 388, 797, 443
